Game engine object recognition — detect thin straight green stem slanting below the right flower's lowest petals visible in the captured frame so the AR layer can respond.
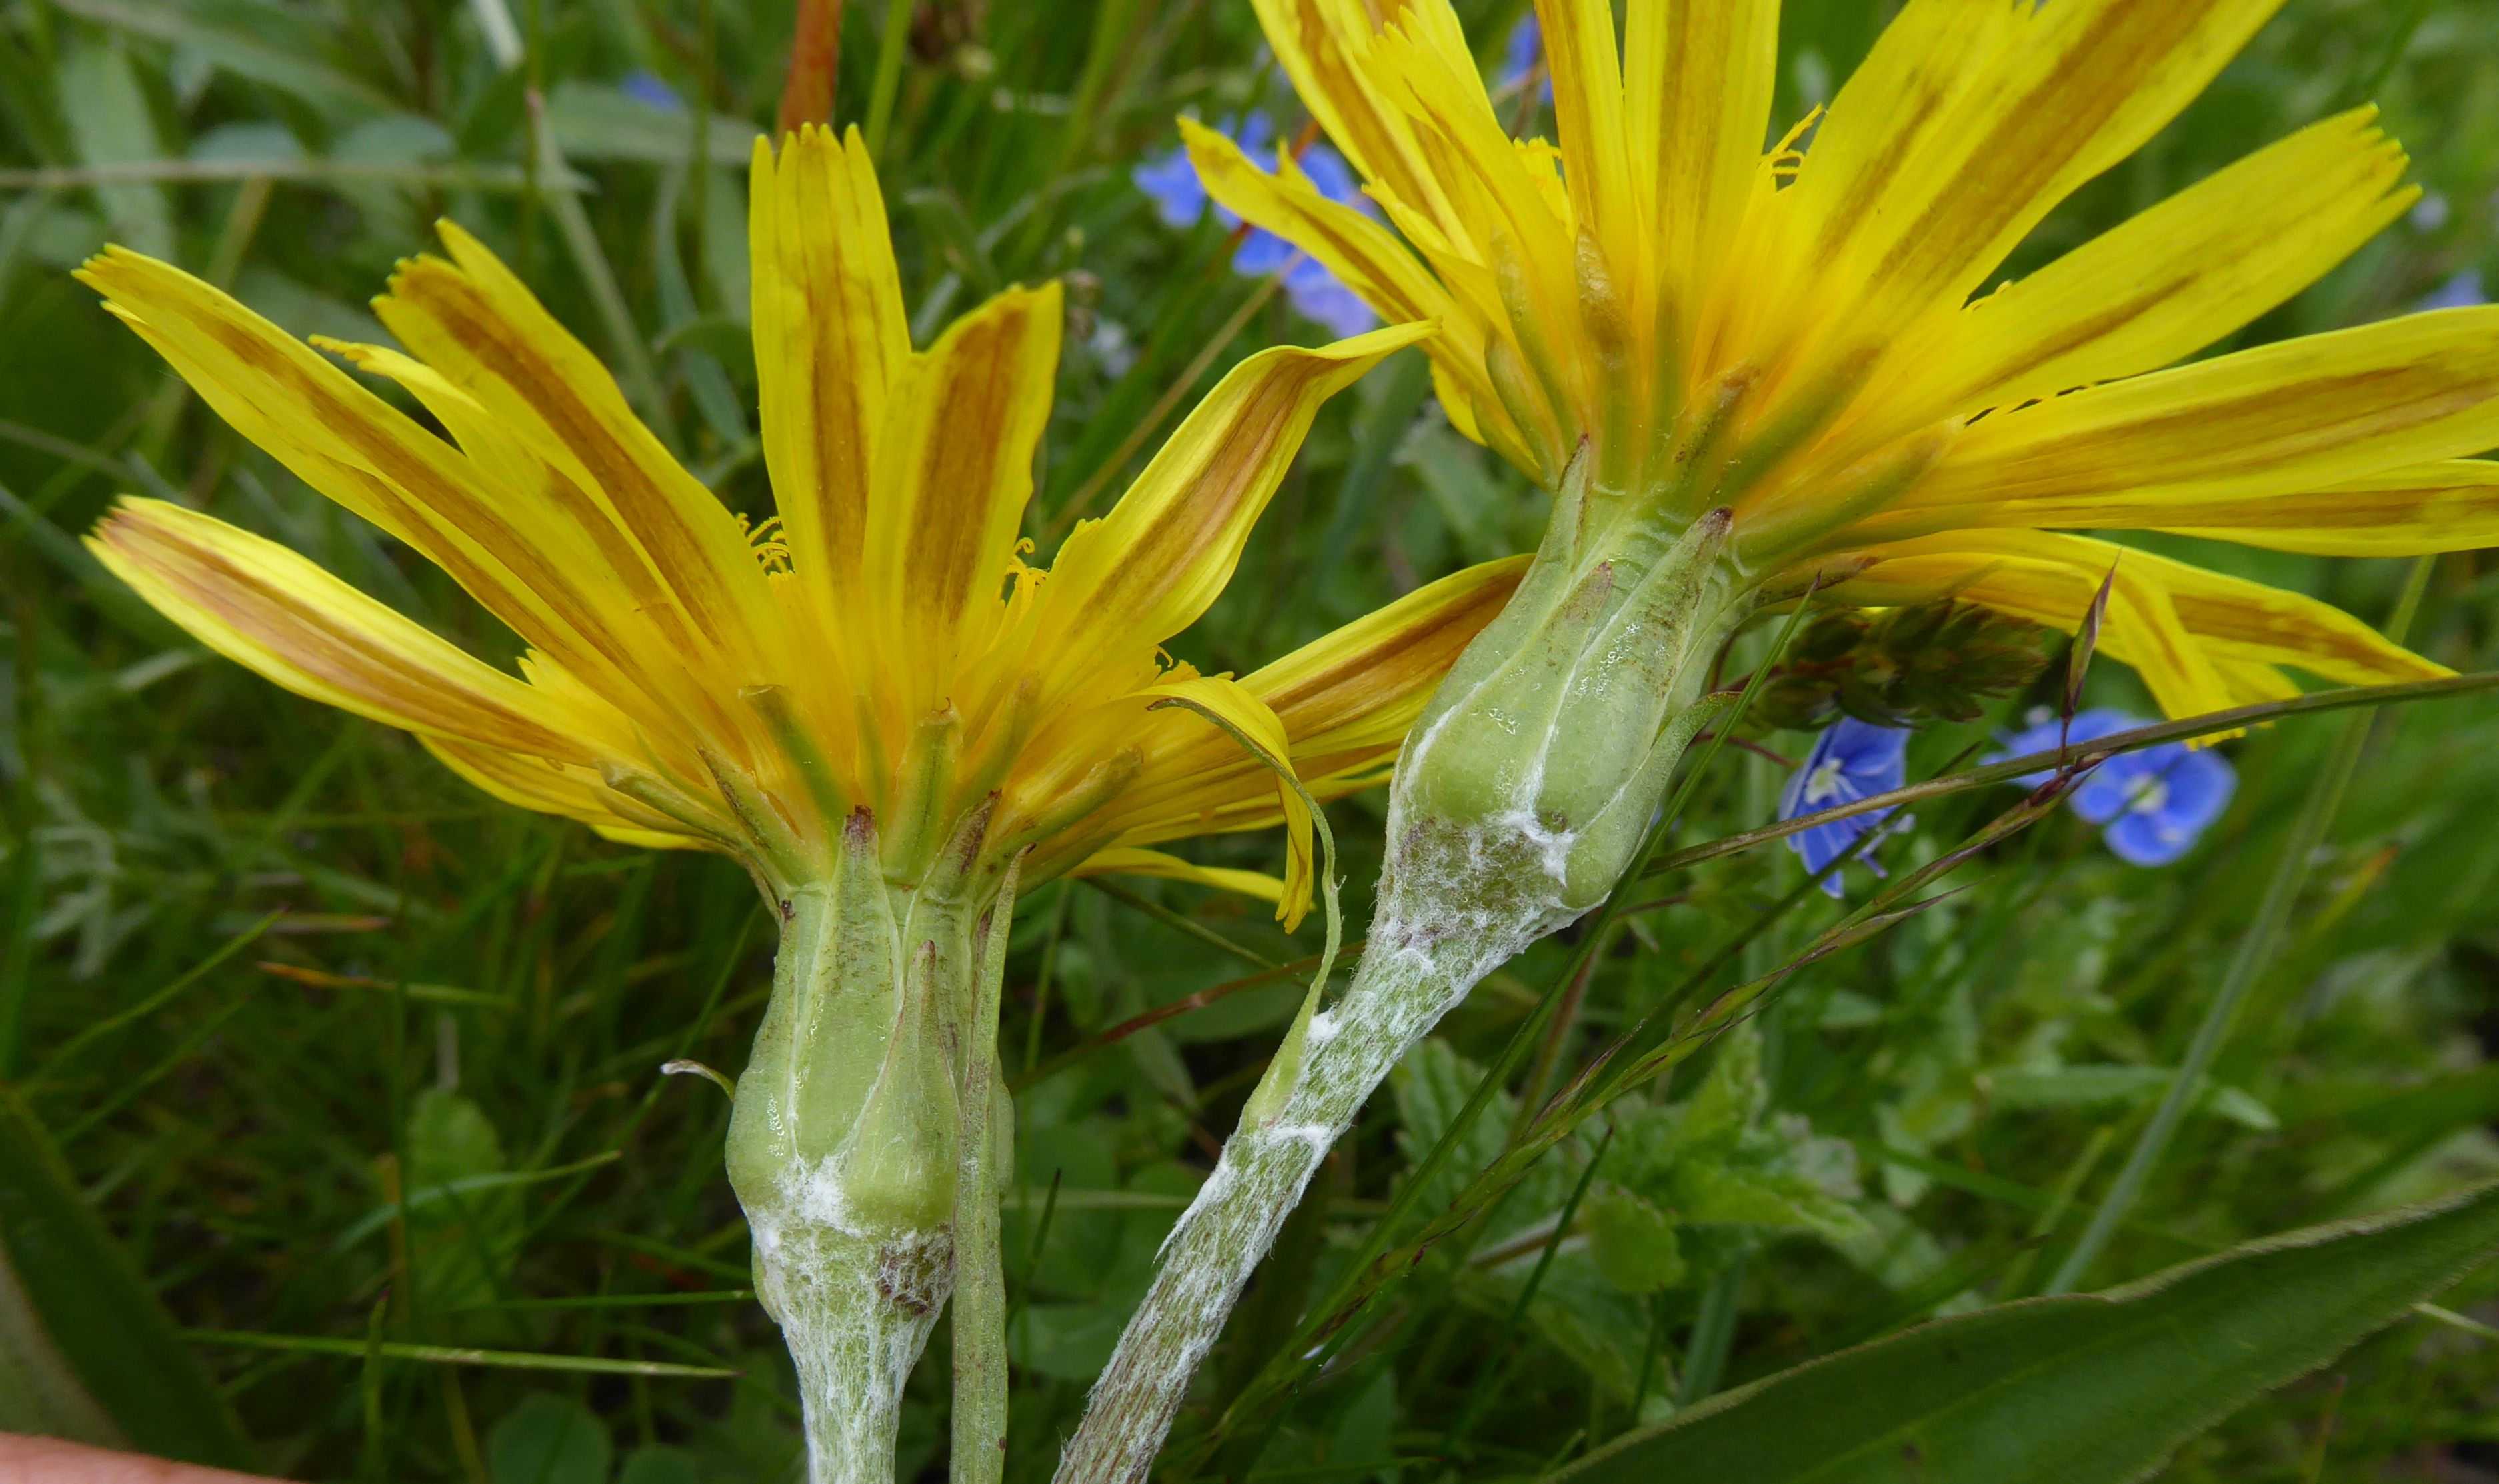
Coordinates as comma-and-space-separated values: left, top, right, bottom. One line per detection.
2047, 557, 2436, 1297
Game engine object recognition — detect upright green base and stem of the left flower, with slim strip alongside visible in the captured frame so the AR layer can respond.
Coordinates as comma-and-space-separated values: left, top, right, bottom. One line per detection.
727, 812, 1017, 1484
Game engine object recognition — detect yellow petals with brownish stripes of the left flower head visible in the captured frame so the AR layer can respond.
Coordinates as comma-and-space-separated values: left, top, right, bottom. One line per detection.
80, 127, 1517, 919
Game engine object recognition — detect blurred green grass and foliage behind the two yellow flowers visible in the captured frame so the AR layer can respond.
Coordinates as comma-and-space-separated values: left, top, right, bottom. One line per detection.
0, 0, 2499, 1484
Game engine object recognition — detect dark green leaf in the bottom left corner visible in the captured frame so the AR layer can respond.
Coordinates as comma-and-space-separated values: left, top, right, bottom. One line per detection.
0, 1097, 255, 1469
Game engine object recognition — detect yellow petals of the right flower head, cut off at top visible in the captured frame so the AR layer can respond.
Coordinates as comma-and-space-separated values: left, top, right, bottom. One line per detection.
1182, 0, 2499, 715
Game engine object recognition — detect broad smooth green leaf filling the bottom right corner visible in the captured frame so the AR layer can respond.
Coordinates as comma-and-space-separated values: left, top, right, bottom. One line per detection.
1554, 1187, 2499, 1484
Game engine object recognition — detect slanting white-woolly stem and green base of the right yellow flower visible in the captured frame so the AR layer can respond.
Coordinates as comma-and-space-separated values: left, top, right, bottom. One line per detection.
1057, 460, 1752, 1484
